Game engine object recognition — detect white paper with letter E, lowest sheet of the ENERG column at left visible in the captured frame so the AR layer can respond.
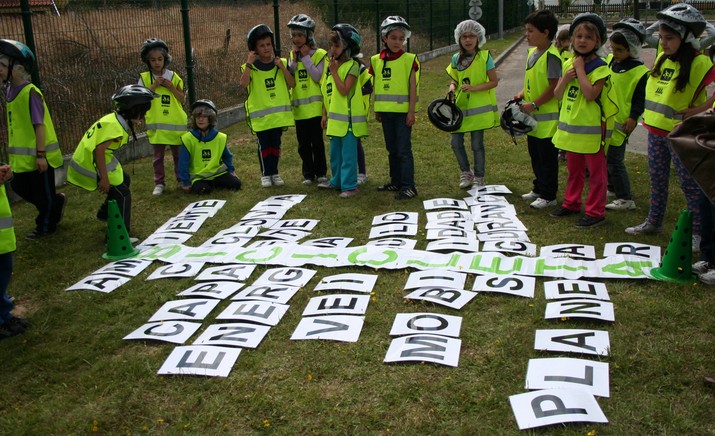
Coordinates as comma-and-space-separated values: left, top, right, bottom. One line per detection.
157, 345, 241, 377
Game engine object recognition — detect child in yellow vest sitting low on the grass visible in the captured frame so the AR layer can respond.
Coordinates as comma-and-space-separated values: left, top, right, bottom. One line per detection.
179, 100, 241, 194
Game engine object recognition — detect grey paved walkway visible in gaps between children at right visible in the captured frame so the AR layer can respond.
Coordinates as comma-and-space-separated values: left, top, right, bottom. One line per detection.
496, 40, 655, 154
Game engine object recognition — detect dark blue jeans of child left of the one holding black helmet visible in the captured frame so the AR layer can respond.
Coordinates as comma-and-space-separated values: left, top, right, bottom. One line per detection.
381, 112, 415, 189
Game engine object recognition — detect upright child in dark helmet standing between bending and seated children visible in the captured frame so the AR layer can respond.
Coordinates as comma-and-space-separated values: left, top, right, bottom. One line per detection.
139, 38, 186, 195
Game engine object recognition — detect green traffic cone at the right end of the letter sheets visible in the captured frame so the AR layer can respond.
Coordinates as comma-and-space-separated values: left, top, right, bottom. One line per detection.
650, 210, 697, 283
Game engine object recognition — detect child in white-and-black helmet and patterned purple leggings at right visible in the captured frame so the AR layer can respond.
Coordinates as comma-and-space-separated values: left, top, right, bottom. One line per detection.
626, 3, 715, 245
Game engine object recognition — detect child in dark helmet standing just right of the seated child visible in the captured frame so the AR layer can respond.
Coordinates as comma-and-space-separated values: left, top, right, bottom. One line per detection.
241, 24, 295, 188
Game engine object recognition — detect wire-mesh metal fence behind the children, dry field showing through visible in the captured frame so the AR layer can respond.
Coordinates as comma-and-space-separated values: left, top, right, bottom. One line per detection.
0, 0, 529, 157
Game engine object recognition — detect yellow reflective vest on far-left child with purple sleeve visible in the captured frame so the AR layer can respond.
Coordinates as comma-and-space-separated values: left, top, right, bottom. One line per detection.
5, 83, 63, 173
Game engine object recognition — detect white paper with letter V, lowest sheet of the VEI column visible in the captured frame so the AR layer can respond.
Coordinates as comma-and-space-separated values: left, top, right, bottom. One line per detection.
290, 315, 365, 342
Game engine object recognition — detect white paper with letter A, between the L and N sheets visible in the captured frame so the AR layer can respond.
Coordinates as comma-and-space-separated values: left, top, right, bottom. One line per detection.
534, 329, 611, 356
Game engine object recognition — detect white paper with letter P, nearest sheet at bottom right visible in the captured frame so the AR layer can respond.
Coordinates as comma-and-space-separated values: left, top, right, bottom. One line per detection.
509, 389, 608, 430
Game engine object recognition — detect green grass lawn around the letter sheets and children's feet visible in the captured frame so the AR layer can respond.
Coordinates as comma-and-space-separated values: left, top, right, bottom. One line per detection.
0, 30, 715, 435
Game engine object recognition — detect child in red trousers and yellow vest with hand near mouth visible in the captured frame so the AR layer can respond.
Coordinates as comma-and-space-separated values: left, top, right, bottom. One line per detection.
551, 13, 617, 229
